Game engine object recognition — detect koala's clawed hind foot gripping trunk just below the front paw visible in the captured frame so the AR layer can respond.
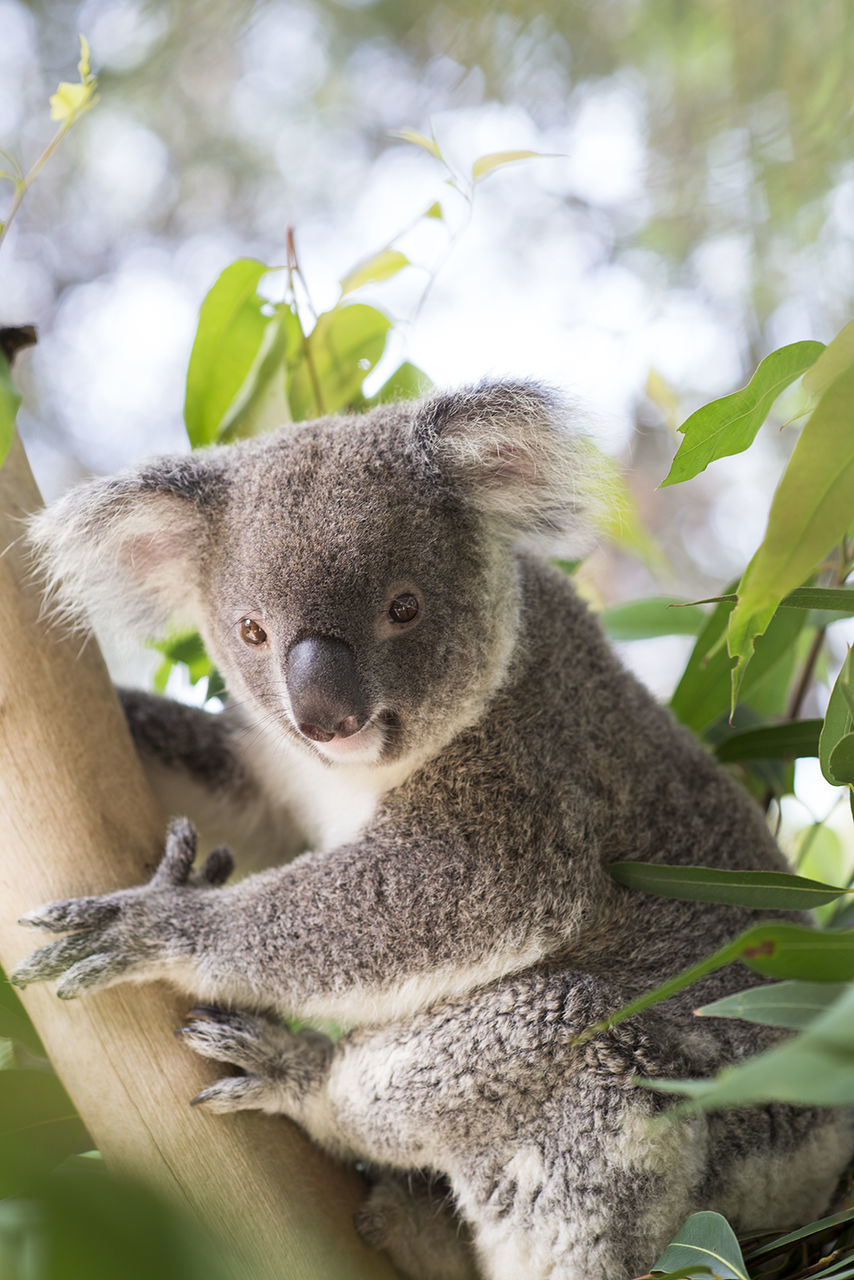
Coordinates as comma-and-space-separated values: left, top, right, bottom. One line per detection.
175, 1005, 333, 1115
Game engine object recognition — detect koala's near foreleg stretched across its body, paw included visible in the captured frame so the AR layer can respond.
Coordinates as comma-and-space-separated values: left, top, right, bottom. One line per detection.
15, 803, 590, 1024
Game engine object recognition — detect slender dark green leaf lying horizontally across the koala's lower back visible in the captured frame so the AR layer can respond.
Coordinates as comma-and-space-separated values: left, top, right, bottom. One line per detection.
608, 861, 849, 911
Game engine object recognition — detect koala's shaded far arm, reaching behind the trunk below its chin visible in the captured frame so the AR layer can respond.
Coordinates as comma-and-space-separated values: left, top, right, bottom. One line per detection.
118, 689, 306, 869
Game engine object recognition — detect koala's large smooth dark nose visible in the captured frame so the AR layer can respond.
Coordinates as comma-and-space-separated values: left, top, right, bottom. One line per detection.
284, 636, 367, 742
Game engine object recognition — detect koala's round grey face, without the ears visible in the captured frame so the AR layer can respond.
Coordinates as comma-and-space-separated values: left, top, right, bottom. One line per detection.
204, 415, 516, 763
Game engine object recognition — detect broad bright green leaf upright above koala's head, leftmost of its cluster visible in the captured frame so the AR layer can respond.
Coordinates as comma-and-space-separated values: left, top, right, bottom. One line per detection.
184, 257, 287, 448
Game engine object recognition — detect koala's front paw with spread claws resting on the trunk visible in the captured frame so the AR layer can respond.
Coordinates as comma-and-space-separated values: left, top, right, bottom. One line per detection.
10, 818, 232, 1000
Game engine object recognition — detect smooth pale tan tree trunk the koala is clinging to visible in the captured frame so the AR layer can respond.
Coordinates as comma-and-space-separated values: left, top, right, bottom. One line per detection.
0, 440, 393, 1280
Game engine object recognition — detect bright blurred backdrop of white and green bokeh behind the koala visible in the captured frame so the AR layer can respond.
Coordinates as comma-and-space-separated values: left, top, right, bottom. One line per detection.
0, 0, 854, 839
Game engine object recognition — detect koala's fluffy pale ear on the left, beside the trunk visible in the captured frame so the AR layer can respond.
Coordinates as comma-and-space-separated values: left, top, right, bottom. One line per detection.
28, 451, 224, 635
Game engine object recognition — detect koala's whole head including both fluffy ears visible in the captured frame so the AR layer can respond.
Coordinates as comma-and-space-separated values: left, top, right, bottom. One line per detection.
32, 384, 594, 763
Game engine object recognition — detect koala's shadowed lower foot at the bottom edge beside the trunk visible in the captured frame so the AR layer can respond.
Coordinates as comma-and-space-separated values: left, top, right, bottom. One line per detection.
353, 1172, 480, 1280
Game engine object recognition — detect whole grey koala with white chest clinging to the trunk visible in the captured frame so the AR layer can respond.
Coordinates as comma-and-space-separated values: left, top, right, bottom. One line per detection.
8, 383, 854, 1280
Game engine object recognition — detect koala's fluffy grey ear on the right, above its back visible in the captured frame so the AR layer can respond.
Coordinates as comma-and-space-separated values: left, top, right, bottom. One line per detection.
416, 381, 592, 549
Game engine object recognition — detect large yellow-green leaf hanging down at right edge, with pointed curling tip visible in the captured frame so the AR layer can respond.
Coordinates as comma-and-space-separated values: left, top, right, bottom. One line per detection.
727, 366, 854, 704
